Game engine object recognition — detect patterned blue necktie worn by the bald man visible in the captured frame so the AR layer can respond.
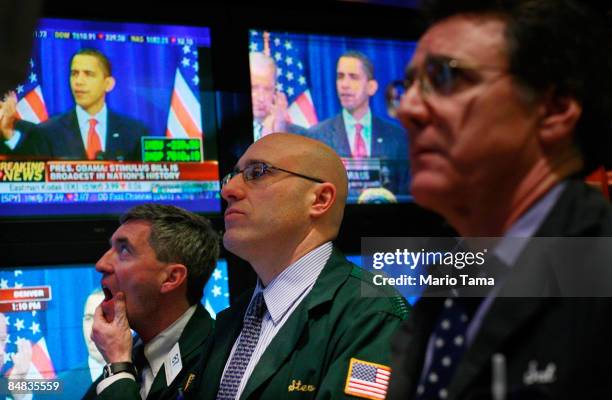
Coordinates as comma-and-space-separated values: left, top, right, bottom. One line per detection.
217, 292, 266, 400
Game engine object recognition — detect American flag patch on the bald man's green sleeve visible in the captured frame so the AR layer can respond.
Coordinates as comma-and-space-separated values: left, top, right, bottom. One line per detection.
344, 358, 391, 399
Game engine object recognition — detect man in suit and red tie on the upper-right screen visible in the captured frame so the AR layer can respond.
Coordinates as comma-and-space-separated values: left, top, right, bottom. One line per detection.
308, 51, 408, 199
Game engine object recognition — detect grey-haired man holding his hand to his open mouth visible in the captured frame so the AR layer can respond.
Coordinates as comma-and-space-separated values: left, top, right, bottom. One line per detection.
82, 204, 219, 400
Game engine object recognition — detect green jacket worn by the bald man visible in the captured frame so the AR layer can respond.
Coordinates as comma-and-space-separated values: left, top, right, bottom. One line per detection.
197, 250, 408, 399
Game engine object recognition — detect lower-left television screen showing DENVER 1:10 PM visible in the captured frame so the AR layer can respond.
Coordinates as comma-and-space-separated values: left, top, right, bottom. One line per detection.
0, 259, 229, 399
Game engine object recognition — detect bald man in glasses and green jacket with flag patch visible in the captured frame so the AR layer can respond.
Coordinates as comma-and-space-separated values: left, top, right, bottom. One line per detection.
201, 133, 408, 399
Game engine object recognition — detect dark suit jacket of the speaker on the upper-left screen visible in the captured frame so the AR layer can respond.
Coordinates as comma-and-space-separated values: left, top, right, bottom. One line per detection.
19, 109, 149, 161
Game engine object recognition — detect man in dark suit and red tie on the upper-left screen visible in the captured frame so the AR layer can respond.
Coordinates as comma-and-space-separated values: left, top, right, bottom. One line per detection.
19, 49, 148, 161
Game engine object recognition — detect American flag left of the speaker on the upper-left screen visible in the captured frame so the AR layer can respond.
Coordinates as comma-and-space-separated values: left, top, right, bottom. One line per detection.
15, 58, 49, 124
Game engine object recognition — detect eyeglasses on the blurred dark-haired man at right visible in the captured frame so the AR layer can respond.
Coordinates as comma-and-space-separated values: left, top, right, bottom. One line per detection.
386, 54, 508, 109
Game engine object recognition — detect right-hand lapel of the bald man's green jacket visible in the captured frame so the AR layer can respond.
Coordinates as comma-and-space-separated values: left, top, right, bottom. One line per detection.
241, 249, 351, 399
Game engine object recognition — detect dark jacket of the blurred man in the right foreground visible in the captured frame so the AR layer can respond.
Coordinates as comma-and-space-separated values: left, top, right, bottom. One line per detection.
388, 180, 612, 400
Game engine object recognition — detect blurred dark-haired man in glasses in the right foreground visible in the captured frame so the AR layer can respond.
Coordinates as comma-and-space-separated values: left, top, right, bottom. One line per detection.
389, 0, 612, 399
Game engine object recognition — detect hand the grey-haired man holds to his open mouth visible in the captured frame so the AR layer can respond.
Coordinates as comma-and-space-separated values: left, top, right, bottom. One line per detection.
91, 292, 132, 363
